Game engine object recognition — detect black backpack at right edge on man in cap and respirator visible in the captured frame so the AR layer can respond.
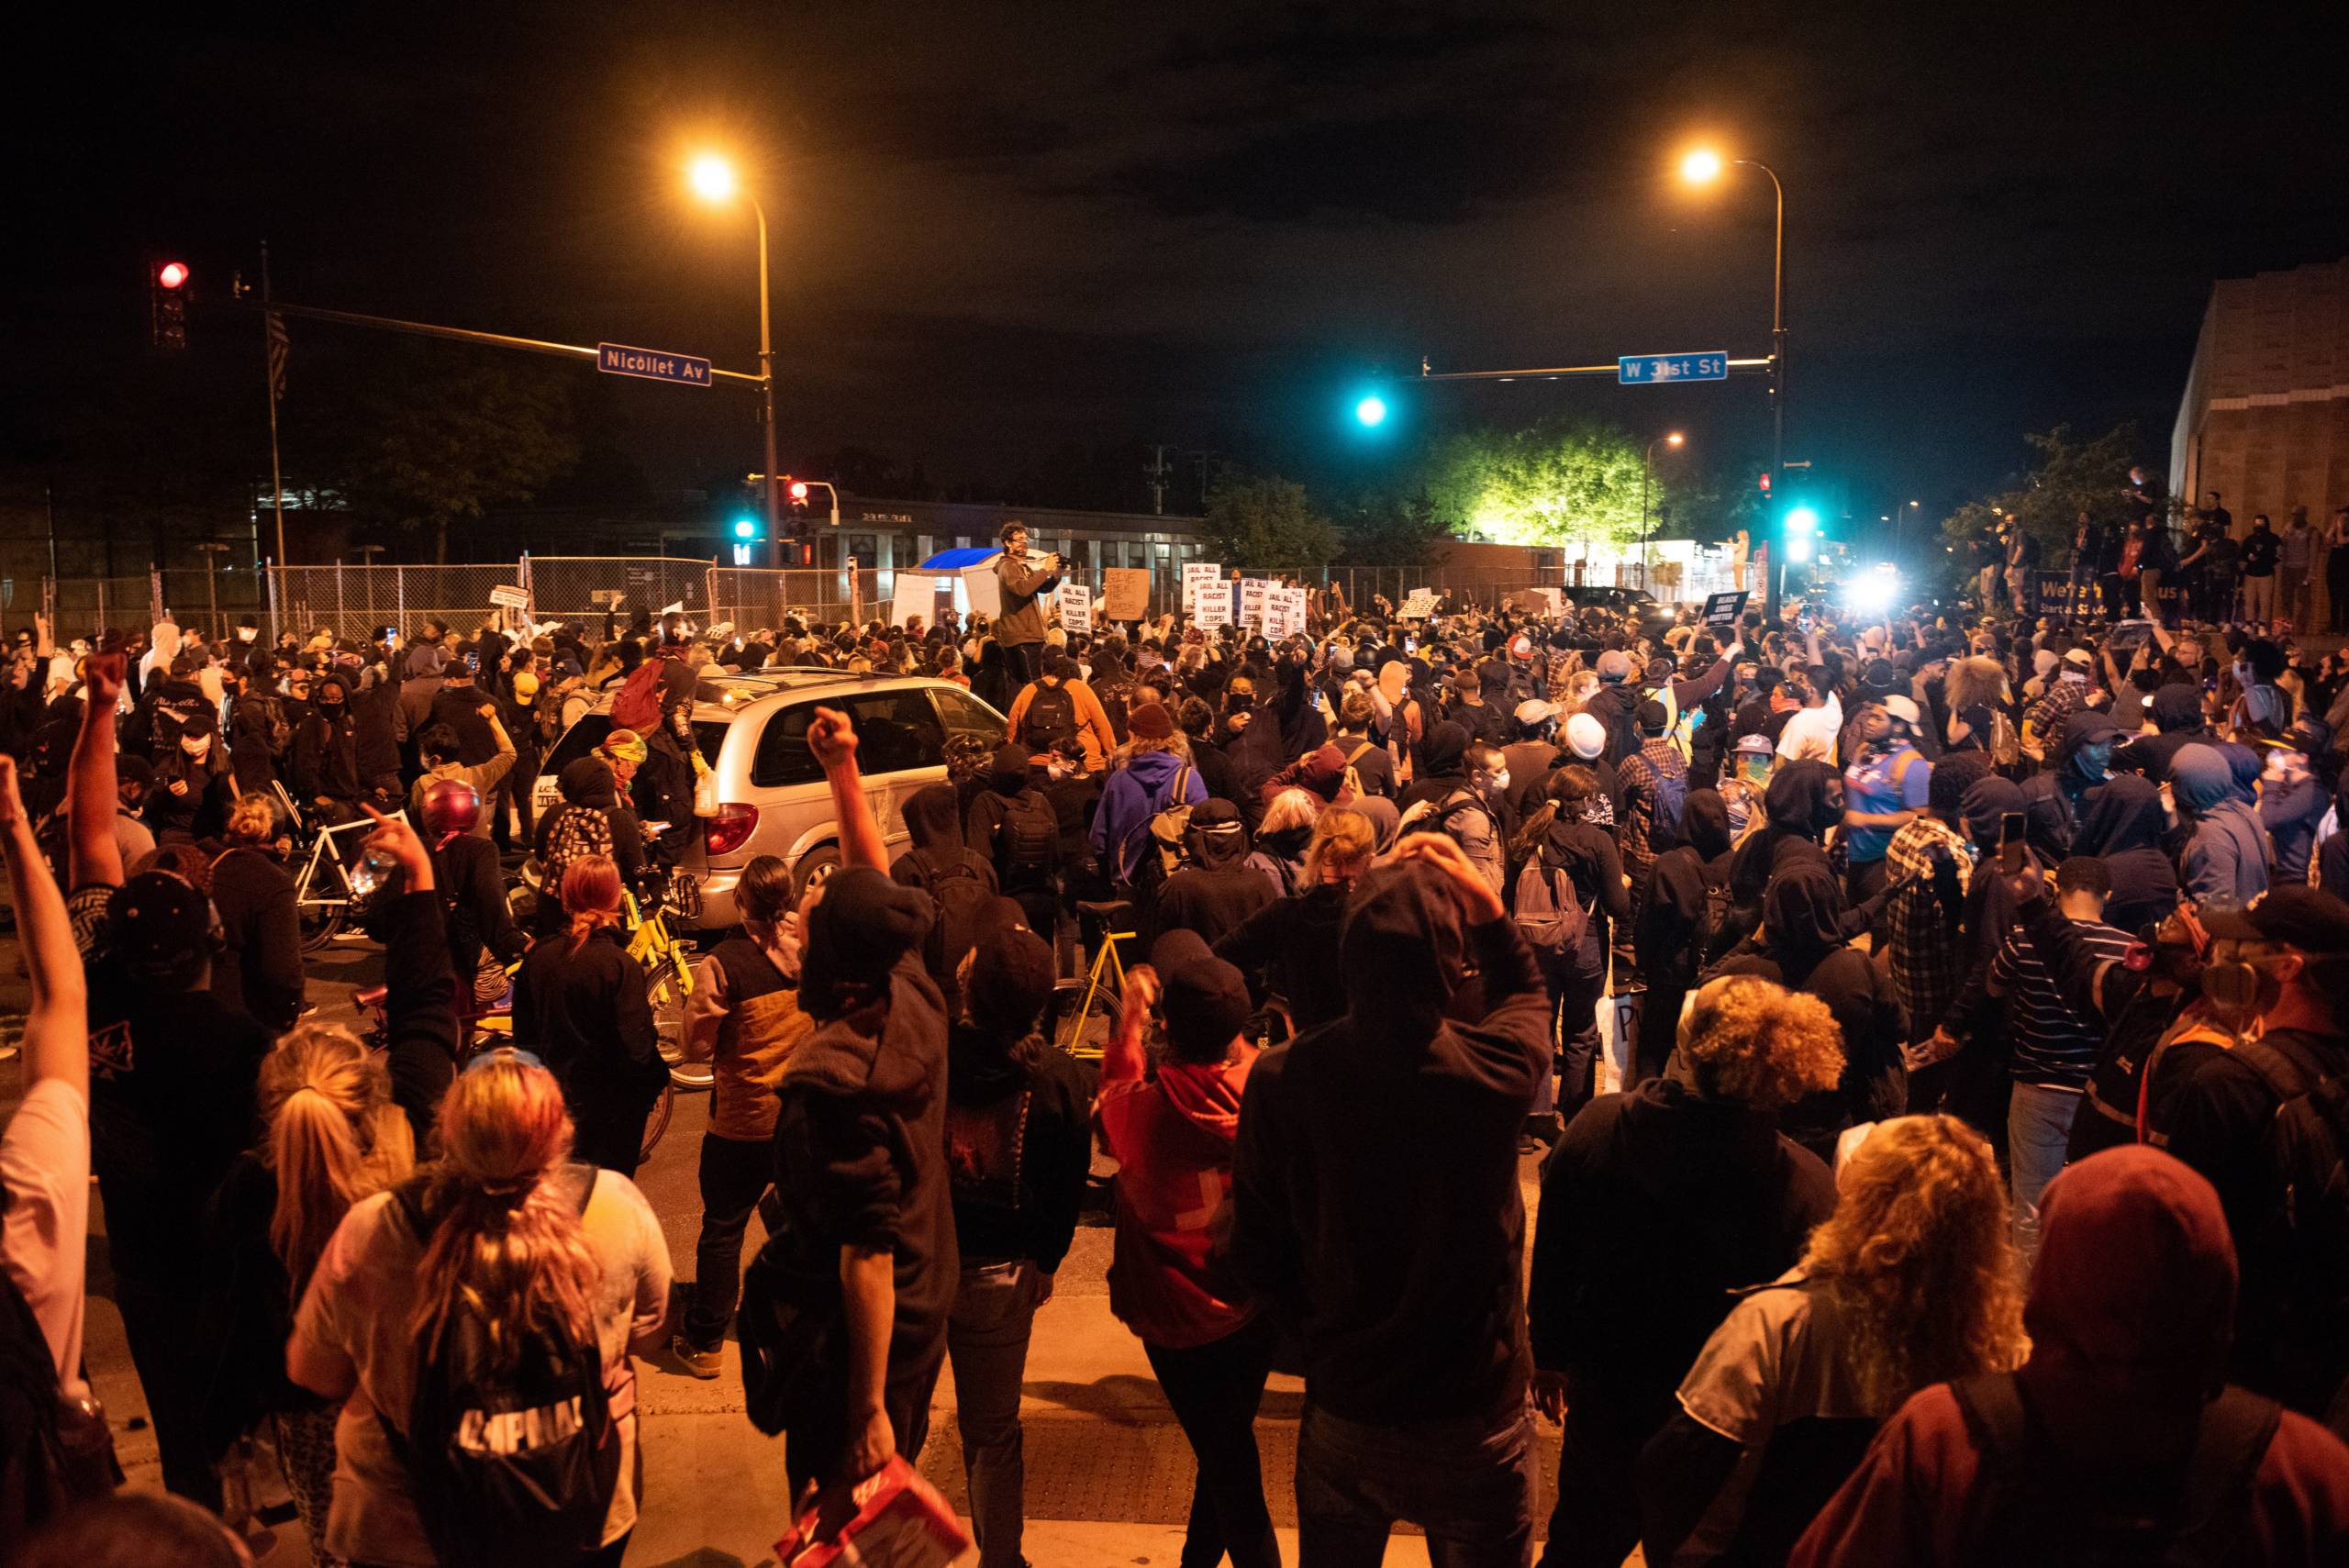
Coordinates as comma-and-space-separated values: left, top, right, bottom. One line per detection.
2234, 1030, 2349, 1413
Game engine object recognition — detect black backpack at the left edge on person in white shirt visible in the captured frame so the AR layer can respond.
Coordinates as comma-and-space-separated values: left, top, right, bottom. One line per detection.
0, 1270, 122, 1556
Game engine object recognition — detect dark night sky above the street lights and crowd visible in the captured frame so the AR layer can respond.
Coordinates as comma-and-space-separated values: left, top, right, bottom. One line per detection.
7, 0, 2349, 526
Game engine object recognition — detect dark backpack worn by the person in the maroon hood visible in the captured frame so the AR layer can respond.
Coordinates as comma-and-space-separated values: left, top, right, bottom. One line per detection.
1950, 1373, 2283, 1568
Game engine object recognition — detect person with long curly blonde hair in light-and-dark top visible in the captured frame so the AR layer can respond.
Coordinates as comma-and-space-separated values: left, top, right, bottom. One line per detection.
1640, 1115, 2030, 1565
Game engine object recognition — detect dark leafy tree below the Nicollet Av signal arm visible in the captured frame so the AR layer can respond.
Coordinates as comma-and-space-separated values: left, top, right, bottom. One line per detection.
348, 350, 580, 561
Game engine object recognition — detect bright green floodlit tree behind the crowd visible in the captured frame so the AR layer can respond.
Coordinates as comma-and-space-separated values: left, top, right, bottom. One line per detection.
1426, 420, 1665, 547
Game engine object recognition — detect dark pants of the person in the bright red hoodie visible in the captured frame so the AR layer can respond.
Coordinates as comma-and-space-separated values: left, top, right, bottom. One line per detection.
1141, 1317, 1277, 1568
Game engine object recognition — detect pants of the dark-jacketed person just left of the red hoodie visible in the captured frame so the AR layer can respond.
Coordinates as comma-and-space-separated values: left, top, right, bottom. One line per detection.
947, 1258, 1043, 1568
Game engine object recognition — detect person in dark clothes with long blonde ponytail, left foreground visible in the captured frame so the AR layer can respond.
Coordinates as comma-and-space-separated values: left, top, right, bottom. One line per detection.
193, 1026, 416, 1568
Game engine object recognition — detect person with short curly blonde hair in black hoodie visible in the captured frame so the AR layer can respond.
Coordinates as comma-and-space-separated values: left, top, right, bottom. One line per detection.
1527, 976, 1844, 1568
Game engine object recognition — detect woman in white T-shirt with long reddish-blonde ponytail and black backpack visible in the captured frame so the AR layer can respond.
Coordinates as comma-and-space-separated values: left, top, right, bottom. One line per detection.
286, 1050, 670, 1568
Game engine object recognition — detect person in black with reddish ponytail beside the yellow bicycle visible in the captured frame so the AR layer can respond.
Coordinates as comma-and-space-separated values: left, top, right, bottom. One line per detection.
515, 854, 670, 1176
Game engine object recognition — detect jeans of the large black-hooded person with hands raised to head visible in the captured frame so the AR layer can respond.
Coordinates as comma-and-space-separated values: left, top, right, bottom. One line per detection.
1297, 1392, 1536, 1568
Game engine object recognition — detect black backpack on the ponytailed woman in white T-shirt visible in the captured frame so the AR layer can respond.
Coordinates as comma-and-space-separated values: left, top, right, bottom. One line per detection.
378, 1164, 620, 1568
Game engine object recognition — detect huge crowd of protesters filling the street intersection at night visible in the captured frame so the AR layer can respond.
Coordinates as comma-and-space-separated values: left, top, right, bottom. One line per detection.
14, 497, 2349, 1568
